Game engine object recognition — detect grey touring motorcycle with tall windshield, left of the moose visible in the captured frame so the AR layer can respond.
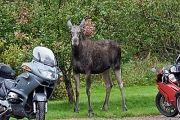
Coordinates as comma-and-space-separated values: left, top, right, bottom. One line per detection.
0, 46, 63, 120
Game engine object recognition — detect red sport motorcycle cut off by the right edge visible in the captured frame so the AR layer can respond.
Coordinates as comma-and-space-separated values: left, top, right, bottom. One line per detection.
152, 55, 180, 117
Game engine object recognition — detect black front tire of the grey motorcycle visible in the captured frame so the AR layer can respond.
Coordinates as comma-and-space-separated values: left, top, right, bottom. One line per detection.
36, 102, 46, 120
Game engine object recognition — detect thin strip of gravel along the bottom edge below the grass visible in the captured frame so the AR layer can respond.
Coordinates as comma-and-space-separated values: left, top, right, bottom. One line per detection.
58, 115, 180, 120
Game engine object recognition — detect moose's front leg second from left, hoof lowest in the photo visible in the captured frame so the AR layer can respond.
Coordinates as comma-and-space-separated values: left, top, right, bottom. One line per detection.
86, 72, 94, 116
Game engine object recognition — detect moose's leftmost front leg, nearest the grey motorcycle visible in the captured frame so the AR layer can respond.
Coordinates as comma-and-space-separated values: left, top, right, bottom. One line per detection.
74, 74, 80, 112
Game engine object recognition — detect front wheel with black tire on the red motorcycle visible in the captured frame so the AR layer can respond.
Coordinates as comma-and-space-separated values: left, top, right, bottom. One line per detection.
156, 92, 178, 117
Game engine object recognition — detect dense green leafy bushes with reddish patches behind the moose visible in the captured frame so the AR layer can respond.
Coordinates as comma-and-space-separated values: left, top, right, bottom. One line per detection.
0, 0, 180, 98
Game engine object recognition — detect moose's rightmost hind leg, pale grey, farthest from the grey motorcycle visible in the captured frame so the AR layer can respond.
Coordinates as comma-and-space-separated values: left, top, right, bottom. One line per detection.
114, 69, 127, 111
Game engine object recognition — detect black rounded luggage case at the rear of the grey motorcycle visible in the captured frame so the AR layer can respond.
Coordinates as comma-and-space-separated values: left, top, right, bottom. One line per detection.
0, 63, 16, 79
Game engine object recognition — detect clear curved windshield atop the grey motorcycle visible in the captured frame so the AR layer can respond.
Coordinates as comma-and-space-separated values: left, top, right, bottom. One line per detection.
33, 46, 56, 66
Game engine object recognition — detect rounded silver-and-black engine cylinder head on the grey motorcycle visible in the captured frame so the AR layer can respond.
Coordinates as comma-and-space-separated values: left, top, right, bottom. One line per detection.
7, 92, 20, 104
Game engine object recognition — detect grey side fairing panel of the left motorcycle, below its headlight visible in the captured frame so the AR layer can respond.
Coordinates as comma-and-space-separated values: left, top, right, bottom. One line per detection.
5, 72, 42, 118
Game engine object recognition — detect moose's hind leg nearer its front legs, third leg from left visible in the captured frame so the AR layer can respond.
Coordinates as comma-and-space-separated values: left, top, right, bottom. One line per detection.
102, 70, 112, 110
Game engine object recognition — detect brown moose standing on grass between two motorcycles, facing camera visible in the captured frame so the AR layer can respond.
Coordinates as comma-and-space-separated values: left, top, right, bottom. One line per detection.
67, 19, 127, 116
